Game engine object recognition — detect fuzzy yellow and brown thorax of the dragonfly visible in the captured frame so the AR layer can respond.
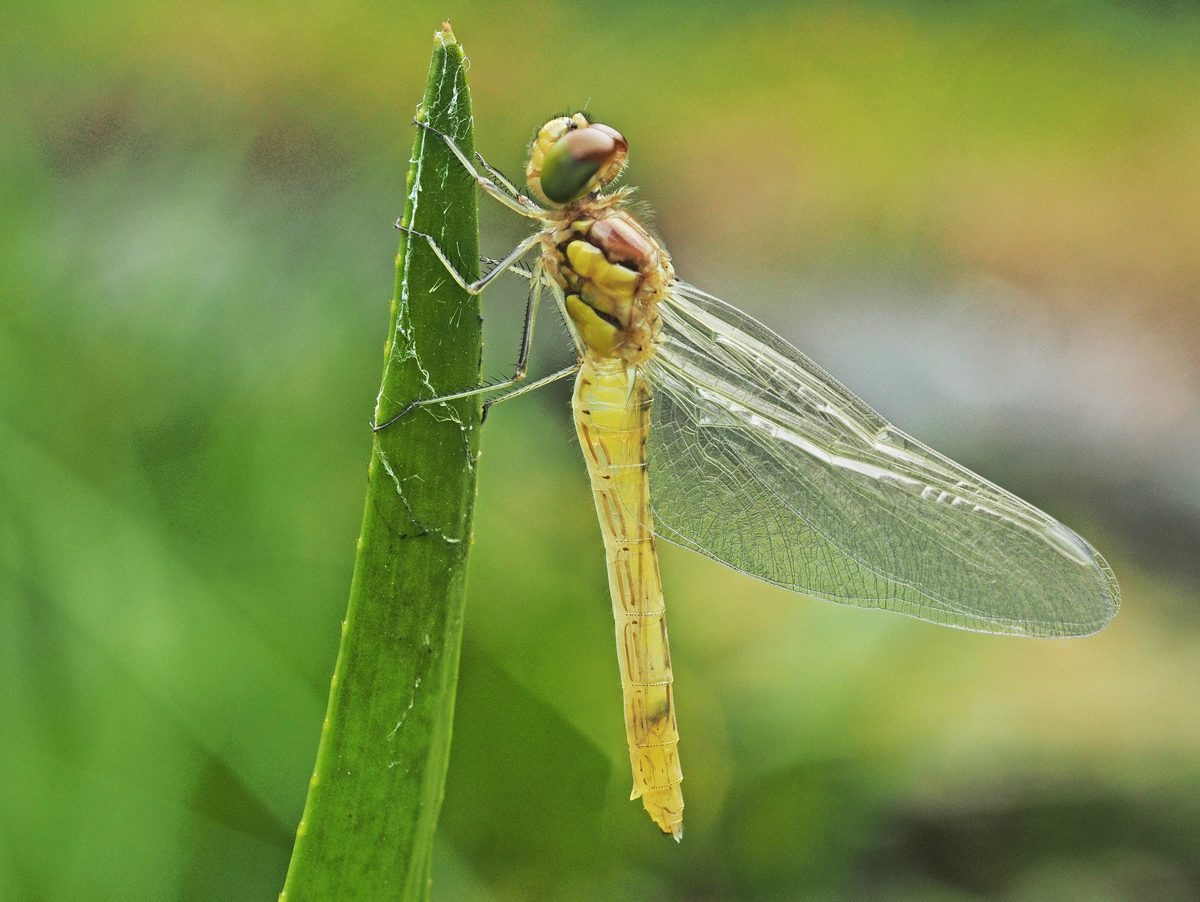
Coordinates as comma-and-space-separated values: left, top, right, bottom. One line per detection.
542, 209, 674, 366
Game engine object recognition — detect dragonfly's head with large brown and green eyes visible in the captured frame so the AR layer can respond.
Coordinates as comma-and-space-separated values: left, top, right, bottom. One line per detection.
526, 113, 629, 206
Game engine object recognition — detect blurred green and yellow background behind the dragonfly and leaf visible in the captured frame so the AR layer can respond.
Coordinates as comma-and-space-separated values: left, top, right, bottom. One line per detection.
0, 0, 1200, 902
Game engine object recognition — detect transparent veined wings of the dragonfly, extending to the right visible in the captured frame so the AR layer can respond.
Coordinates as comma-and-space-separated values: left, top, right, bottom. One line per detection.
646, 283, 1120, 636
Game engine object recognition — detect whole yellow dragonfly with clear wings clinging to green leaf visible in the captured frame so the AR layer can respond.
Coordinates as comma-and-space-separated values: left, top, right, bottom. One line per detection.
374, 113, 1121, 841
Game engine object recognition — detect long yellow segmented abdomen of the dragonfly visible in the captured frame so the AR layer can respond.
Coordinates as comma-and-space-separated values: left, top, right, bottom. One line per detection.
572, 355, 683, 840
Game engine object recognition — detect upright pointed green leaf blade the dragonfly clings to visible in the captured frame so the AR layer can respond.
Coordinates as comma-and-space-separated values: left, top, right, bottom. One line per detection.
281, 25, 482, 902
